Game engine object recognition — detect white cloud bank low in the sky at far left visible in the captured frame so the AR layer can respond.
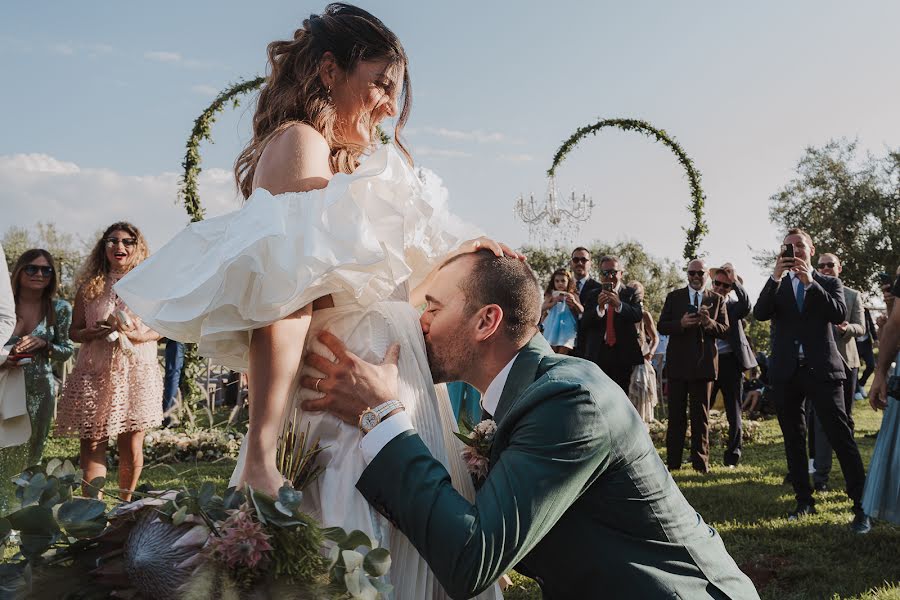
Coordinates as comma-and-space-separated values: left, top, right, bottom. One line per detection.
0, 154, 241, 254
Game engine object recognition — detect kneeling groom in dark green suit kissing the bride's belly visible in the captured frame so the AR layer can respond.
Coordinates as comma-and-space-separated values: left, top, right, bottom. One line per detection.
301, 251, 758, 600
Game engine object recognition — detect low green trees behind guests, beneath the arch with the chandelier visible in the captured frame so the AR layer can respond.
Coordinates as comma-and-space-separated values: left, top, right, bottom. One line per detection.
522, 240, 685, 319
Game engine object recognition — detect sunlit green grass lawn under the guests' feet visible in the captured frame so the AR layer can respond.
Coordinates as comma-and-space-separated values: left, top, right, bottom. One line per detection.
10, 402, 900, 600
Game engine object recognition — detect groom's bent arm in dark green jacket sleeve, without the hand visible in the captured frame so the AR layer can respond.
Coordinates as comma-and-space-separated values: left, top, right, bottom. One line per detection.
357, 381, 610, 598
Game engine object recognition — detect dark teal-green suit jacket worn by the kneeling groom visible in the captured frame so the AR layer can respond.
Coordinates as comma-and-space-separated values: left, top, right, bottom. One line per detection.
357, 335, 759, 600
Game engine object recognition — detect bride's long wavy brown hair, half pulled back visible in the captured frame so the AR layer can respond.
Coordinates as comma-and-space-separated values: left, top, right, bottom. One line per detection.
234, 3, 412, 198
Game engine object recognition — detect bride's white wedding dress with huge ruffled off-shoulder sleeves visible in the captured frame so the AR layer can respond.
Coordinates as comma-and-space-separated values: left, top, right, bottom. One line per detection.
115, 145, 501, 600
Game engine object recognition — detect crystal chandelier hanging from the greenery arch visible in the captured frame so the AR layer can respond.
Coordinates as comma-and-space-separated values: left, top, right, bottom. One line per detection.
515, 176, 594, 248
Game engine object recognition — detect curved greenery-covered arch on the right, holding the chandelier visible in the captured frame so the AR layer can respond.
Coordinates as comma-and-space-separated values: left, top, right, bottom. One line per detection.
547, 119, 709, 261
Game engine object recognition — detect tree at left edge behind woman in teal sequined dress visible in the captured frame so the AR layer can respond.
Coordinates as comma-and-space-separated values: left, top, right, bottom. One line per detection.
2, 222, 85, 302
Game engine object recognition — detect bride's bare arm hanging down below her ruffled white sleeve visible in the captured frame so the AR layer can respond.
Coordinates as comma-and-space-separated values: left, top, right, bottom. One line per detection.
240, 305, 312, 494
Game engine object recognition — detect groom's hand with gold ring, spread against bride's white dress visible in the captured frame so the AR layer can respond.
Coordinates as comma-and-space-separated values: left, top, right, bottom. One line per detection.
300, 331, 400, 425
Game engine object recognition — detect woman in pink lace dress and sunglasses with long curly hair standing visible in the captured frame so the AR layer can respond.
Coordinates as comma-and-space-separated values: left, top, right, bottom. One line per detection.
56, 223, 162, 500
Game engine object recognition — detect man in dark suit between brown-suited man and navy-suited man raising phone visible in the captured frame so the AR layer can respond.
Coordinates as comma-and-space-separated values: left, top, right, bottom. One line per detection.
710, 263, 757, 467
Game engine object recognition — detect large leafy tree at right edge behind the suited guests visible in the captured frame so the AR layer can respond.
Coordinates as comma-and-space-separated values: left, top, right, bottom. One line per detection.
757, 140, 900, 292
